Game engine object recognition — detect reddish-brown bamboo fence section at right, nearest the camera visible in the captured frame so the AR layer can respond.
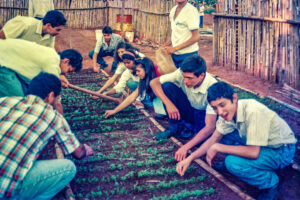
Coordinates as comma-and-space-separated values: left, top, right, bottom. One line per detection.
213, 0, 300, 90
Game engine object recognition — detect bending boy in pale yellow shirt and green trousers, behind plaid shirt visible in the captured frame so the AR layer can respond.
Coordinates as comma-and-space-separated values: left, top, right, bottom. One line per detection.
0, 39, 82, 113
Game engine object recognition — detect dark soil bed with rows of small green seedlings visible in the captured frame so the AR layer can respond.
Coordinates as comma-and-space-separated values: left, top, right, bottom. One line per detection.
57, 71, 244, 200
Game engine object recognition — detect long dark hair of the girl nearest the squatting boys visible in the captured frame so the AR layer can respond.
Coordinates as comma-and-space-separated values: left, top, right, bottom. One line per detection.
133, 57, 157, 101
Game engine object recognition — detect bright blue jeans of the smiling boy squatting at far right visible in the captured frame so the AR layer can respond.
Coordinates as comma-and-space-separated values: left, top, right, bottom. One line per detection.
221, 131, 296, 189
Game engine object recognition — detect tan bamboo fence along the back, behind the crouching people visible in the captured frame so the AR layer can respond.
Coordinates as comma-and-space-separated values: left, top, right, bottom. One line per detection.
0, 0, 176, 43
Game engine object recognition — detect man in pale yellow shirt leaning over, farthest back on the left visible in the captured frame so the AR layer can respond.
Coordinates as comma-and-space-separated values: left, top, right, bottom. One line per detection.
0, 10, 67, 48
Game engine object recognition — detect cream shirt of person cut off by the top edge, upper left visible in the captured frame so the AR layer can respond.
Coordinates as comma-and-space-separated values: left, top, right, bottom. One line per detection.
28, 0, 54, 18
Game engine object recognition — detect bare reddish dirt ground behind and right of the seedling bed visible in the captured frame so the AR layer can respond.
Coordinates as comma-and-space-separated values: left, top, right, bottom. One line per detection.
56, 15, 300, 108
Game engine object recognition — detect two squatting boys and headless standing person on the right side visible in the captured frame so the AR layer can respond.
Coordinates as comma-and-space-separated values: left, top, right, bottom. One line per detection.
150, 0, 297, 200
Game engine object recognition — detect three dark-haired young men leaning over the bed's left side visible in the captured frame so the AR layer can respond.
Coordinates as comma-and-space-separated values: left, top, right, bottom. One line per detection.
0, 6, 93, 199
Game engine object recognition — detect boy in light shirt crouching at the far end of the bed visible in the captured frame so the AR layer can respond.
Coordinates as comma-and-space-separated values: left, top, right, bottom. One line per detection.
89, 26, 122, 73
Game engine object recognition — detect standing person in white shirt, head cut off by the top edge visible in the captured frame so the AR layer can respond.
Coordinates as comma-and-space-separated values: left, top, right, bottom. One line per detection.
164, 0, 199, 68
